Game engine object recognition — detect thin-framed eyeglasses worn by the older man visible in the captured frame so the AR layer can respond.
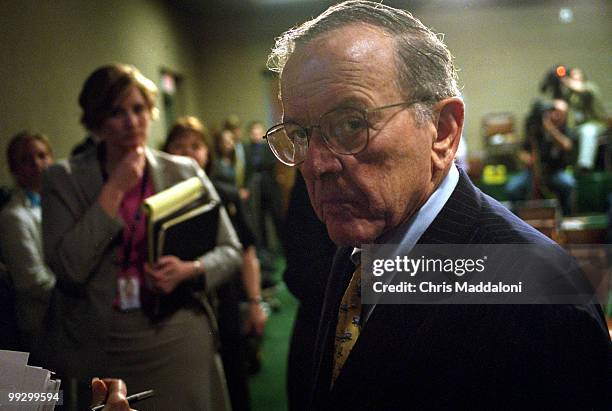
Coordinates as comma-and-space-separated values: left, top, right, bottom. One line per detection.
264, 101, 417, 166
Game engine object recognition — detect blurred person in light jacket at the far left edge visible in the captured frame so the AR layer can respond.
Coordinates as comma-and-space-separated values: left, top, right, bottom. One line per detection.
0, 131, 55, 351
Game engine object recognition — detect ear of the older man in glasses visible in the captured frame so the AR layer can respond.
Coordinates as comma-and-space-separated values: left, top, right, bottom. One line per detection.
431, 97, 464, 171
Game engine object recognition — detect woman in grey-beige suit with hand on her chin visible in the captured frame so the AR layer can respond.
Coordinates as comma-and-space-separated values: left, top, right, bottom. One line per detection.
39, 64, 241, 410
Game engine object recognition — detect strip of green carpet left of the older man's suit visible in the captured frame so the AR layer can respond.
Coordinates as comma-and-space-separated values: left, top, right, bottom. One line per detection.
249, 261, 298, 411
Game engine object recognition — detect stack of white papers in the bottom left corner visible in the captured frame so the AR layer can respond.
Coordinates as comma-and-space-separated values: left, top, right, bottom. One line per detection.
0, 350, 60, 411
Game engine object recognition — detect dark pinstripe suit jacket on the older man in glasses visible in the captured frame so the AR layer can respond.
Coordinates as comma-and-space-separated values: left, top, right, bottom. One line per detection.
310, 173, 612, 410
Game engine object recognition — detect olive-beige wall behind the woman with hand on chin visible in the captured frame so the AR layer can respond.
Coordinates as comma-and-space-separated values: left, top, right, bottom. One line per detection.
0, 0, 197, 184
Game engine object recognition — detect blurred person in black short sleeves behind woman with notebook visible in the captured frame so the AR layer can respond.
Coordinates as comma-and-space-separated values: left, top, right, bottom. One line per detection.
163, 116, 267, 411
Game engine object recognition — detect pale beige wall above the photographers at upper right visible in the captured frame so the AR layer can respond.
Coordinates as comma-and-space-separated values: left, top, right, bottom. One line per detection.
421, 1, 612, 154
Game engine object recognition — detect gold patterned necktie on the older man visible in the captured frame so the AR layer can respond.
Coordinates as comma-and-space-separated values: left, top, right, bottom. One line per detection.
332, 264, 361, 385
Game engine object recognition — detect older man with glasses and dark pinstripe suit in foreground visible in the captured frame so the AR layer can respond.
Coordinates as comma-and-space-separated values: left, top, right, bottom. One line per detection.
266, 1, 611, 410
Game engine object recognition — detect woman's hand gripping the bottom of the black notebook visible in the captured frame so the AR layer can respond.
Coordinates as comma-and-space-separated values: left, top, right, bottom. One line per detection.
145, 255, 202, 294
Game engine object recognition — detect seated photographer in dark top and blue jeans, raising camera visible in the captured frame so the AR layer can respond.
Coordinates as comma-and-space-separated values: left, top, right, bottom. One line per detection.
506, 99, 576, 215
